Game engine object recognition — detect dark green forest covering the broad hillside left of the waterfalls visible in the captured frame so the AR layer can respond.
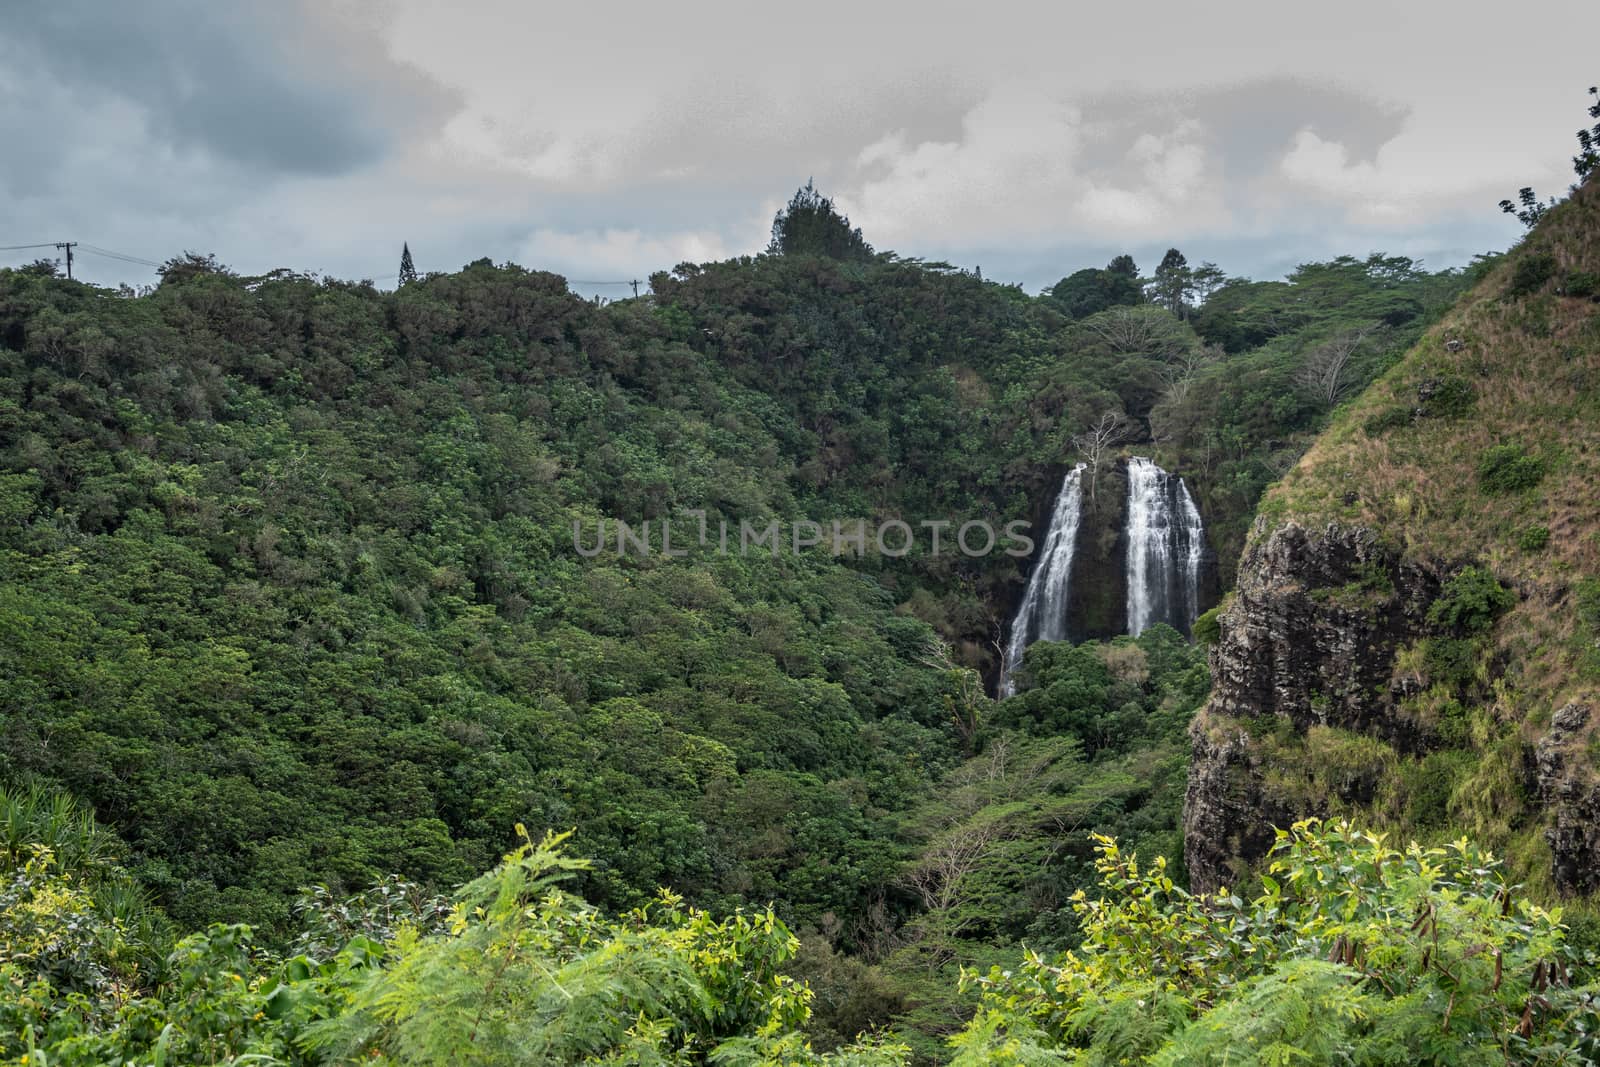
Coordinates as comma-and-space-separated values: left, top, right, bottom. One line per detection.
0, 225, 1456, 931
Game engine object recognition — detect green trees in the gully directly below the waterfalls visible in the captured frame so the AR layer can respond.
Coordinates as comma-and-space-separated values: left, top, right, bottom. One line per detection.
838, 625, 1210, 1062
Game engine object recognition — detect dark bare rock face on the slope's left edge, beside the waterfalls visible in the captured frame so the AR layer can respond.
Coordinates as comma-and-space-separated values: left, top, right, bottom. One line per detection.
1184, 523, 1440, 889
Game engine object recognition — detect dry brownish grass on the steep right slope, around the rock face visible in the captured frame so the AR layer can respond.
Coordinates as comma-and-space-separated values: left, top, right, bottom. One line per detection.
1253, 181, 1600, 891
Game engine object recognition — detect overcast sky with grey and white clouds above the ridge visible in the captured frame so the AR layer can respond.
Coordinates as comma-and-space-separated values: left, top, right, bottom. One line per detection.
0, 0, 1600, 296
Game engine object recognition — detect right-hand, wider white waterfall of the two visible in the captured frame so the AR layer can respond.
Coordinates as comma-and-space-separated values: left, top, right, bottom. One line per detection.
1126, 456, 1205, 635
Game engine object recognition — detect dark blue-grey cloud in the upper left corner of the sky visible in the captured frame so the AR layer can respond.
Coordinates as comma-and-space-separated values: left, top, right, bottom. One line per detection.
6, 0, 456, 174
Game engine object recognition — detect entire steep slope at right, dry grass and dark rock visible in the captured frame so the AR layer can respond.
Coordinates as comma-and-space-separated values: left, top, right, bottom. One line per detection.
1184, 173, 1600, 897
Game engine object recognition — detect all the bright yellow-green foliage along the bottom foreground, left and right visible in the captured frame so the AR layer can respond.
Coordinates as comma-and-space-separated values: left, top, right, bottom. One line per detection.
0, 822, 1600, 1067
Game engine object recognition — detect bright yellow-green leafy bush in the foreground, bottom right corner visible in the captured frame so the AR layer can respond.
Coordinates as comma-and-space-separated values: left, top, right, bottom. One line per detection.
957, 821, 1600, 1067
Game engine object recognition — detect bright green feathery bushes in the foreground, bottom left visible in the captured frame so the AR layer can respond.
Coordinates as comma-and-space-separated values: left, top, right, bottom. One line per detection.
0, 837, 904, 1067
